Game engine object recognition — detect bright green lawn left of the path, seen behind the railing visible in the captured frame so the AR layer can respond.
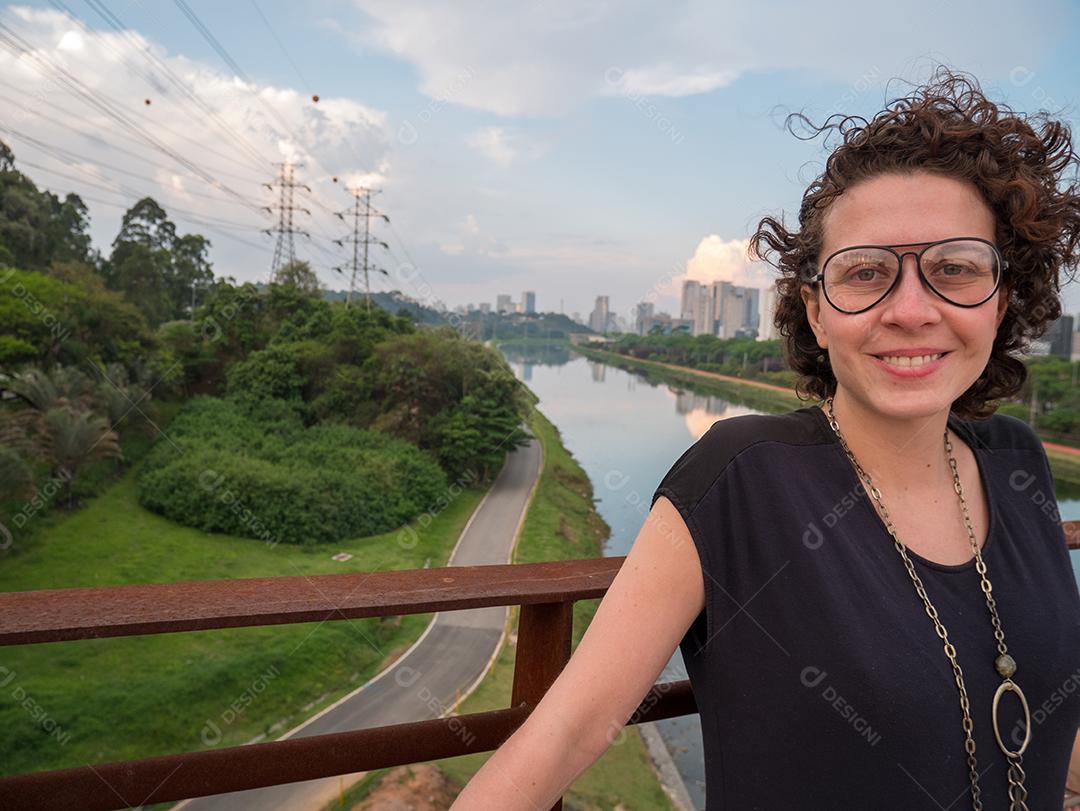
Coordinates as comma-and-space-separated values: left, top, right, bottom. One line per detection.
0, 462, 484, 774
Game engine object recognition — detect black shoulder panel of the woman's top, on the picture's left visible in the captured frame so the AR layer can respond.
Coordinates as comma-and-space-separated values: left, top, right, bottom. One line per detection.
652, 406, 829, 511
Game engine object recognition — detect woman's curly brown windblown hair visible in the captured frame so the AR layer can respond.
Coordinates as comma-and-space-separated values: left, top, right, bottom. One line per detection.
747, 66, 1080, 419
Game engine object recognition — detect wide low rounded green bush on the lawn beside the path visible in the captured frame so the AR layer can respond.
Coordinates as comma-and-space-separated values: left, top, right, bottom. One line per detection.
138, 397, 447, 544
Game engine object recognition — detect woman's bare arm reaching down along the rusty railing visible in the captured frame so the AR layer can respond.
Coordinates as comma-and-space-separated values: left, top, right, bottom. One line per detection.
451, 497, 705, 811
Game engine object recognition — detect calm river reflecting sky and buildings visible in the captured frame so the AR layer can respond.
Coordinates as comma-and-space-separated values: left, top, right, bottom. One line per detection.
502, 347, 1080, 809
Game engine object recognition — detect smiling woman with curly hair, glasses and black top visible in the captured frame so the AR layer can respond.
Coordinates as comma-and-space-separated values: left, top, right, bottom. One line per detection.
454, 69, 1080, 811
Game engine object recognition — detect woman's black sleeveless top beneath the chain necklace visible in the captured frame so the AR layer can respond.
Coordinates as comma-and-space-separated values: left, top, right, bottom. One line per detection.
652, 406, 1080, 811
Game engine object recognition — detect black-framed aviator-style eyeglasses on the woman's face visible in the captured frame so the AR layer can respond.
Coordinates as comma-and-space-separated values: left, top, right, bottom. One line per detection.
807, 236, 1009, 314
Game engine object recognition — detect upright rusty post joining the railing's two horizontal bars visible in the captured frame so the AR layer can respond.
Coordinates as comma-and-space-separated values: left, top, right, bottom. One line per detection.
510, 603, 573, 811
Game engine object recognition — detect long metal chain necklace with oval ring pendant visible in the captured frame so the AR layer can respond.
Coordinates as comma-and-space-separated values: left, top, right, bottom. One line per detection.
825, 397, 1031, 811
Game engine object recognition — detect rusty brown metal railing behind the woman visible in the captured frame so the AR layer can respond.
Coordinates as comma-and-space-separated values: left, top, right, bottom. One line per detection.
0, 521, 1080, 811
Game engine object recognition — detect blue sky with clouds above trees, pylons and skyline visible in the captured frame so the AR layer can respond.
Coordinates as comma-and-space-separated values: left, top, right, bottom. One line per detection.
0, 0, 1080, 322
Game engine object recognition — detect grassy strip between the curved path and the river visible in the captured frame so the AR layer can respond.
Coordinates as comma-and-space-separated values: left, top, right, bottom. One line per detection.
326, 403, 673, 811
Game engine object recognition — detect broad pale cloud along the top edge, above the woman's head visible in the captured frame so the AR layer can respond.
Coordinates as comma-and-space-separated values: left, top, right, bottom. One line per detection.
353, 0, 1066, 116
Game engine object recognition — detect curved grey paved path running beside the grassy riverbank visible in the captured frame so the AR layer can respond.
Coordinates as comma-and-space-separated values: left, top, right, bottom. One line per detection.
179, 438, 543, 811
